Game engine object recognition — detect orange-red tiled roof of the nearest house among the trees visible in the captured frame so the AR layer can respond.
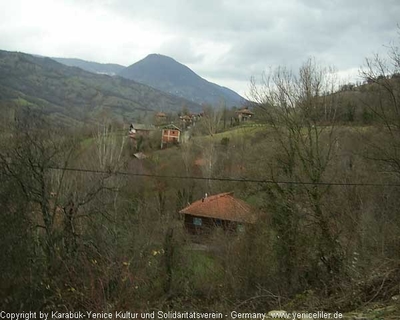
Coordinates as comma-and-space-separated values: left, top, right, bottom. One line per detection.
179, 192, 256, 223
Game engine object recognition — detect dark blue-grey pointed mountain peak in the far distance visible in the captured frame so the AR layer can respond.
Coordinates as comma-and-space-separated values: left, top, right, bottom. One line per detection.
119, 54, 245, 107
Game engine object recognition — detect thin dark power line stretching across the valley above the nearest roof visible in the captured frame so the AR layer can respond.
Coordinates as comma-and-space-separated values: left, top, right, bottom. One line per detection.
36, 166, 400, 187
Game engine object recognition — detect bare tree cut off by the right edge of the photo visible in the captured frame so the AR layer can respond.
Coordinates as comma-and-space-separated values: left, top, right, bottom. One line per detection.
360, 34, 400, 263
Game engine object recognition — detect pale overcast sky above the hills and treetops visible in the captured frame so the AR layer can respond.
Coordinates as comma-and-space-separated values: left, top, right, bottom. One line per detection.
0, 0, 400, 95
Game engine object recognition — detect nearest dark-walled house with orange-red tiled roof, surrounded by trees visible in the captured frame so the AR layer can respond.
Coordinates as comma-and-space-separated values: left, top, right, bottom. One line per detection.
179, 192, 256, 235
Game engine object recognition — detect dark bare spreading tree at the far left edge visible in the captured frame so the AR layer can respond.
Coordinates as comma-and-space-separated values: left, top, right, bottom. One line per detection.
0, 113, 74, 258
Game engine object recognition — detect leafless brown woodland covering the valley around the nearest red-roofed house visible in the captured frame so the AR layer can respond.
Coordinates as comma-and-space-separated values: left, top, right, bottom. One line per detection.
0, 39, 400, 317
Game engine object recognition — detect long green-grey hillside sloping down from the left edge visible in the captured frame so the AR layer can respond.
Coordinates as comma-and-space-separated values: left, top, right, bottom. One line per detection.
0, 50, 201, 122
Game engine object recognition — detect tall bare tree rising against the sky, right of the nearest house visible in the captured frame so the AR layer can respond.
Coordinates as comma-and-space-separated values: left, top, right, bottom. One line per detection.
251, 59, 341, 285
